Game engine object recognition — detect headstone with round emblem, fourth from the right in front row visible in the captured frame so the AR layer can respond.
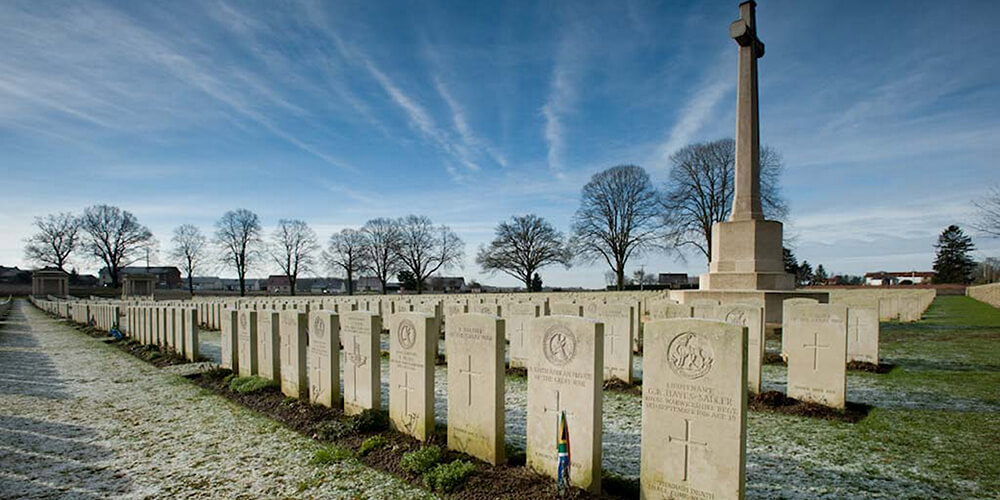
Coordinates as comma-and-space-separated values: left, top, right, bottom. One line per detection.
389, 313, 439, 441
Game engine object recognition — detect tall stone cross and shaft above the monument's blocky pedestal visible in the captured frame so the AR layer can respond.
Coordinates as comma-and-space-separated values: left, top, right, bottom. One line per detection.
729, 0, 764, 221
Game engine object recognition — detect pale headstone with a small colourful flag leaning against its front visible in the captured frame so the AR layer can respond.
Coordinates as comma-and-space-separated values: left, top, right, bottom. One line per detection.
527, 316, 604, 493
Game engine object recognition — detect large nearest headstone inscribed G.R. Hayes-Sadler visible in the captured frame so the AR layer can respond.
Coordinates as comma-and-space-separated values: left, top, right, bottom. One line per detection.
640, 319, 747, 499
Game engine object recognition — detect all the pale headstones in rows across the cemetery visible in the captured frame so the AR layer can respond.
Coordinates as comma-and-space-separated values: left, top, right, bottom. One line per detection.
33, 292, 930, 498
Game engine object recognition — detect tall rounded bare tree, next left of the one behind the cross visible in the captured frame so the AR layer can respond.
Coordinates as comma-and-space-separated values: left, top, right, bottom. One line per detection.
572, 165, 660, 290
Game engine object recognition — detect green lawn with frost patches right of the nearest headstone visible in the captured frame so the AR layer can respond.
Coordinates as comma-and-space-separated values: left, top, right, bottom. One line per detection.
747, 296, 1000, 499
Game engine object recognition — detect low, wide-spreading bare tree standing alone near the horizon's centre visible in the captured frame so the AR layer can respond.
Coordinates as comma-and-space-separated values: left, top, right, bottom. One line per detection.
476, 214, 573, 291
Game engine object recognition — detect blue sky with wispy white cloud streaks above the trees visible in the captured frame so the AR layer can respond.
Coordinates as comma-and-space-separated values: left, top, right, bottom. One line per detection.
0, 0, 1000, 286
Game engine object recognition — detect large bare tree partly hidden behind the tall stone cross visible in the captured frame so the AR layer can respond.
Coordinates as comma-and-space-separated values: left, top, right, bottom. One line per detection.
663, 139, 788, 261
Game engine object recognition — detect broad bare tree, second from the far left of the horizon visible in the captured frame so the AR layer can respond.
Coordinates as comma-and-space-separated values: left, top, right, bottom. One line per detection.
80, 205, 156, 287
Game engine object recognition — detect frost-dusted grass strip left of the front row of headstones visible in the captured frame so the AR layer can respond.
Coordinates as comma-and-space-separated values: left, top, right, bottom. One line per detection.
0, 301, 427, 499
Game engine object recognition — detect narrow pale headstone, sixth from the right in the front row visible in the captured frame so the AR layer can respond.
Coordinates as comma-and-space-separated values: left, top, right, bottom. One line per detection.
307, 309, 340, 408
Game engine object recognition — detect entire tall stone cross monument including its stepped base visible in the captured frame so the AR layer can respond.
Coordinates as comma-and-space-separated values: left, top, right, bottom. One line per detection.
672, 0, 827, 325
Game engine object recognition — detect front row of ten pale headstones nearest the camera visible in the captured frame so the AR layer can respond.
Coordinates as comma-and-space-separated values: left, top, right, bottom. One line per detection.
222, 308, 748, 498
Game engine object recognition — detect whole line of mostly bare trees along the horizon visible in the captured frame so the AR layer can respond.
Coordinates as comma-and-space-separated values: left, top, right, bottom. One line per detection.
33, 139, 1000, 295
